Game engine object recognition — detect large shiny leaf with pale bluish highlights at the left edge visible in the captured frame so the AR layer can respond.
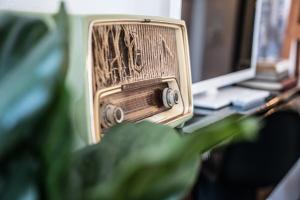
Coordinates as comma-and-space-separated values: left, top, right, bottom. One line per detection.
0, 7, 66, 158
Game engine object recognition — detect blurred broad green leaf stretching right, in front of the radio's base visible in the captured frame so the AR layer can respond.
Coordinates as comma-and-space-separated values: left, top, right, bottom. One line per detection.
74, 117, 257, 200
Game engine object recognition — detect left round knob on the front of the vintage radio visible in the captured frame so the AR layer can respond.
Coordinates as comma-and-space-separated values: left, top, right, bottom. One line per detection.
101, 104, 124, 128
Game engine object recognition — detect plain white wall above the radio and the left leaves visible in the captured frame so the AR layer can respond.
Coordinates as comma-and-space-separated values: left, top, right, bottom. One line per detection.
0, 0, 181, 19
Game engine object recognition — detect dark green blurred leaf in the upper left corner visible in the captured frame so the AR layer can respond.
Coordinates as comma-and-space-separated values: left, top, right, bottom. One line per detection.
0, 14, 49, 77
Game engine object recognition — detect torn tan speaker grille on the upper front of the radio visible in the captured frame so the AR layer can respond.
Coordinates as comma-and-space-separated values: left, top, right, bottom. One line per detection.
92, 23, 179, 92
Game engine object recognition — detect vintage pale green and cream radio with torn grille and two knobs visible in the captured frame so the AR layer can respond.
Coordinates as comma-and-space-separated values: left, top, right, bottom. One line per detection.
67, 16, 192, 144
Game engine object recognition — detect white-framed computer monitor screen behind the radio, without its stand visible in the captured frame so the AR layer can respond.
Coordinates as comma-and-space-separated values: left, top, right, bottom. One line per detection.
182, 0, 262, 95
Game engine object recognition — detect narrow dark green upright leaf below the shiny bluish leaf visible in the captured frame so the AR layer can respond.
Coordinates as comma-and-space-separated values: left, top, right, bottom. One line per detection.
38, 87, 72, 200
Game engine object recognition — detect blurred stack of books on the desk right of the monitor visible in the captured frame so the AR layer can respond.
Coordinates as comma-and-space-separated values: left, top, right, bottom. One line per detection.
241, 60, 297, 92
